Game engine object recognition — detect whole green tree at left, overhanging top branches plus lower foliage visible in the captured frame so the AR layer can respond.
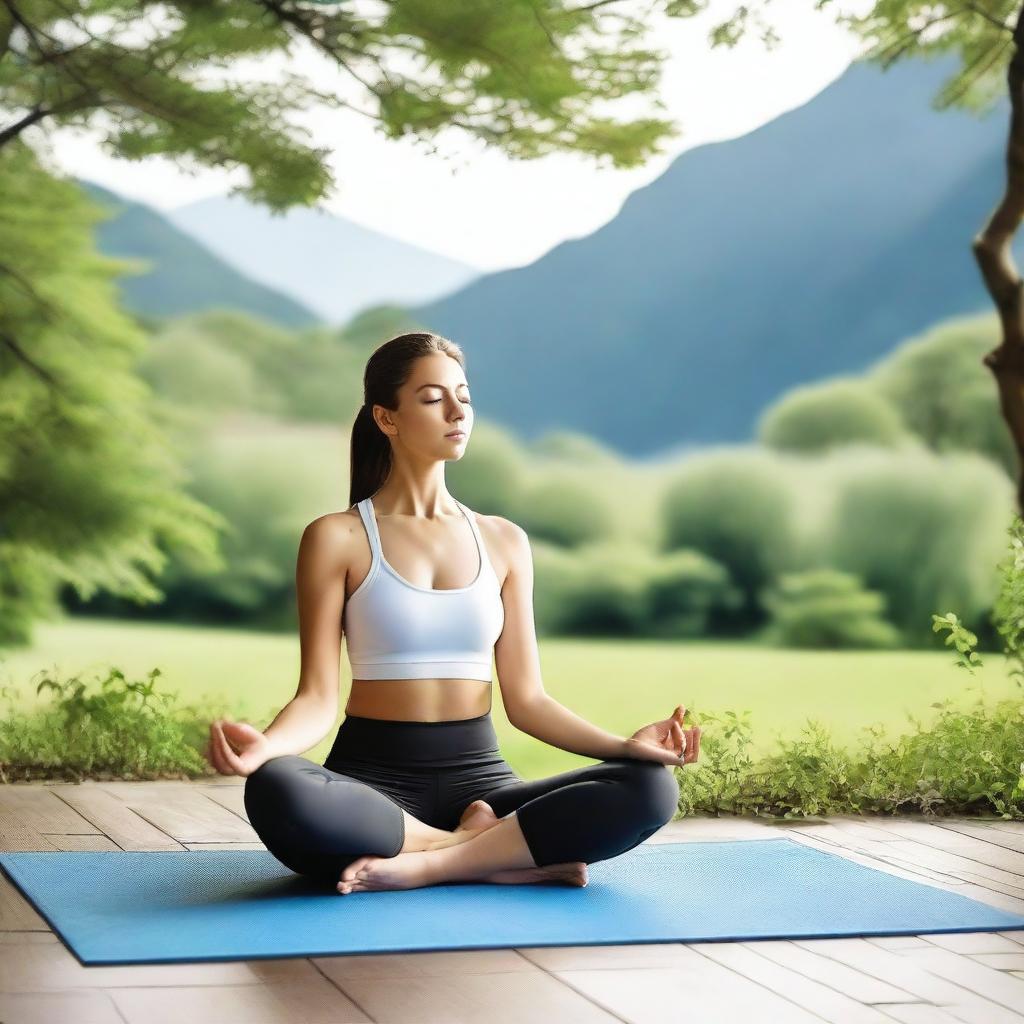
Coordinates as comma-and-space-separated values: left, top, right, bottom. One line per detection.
0, 0, 696, 644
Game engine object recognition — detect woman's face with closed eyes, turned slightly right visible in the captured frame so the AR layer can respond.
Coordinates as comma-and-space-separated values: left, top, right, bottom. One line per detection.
382, 352, 473, 460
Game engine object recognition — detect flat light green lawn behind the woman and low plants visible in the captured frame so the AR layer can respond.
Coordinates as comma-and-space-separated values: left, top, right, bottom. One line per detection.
0, 618, 1021, 778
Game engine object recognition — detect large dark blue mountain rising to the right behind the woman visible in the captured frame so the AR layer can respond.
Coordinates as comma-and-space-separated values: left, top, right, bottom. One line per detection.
410, 58, 1020, 456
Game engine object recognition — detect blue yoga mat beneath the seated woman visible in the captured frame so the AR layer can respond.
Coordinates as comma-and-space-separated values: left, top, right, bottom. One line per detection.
0, 838, 1024, 964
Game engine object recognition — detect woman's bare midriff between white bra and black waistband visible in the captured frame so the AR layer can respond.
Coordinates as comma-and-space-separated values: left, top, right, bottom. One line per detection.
345, 679, 492, 722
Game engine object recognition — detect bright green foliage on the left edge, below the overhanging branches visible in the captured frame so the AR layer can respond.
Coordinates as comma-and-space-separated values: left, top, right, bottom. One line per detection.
0, 140, 223, 645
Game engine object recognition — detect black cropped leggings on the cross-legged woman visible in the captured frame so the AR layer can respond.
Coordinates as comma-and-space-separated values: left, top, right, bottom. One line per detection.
245, 712, 679, 883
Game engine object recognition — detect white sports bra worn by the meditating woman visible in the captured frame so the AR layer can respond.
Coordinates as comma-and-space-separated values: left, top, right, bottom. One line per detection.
342, 498, 505, 683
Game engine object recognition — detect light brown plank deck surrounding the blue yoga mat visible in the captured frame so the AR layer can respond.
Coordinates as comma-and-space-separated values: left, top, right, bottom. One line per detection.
0, 778, 1024, 1024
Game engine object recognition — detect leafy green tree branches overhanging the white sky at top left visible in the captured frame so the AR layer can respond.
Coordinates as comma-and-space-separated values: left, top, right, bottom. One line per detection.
0, 0, 696, 193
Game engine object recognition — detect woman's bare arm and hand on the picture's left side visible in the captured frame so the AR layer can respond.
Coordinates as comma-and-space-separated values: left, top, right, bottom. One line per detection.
205, 515, 352, 774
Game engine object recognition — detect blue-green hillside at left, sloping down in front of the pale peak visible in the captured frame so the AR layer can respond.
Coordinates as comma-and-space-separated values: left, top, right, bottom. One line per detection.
78, 180, 321, 327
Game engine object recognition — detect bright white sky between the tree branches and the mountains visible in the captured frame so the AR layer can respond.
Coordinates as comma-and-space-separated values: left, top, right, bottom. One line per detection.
41, 0, 870, 270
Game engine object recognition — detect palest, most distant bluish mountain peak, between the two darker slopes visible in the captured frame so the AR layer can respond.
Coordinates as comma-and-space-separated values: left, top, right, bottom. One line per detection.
168, 196, 479, 324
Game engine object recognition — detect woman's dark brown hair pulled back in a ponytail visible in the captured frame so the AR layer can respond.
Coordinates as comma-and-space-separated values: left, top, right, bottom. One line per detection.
348, 332, 466, 505
